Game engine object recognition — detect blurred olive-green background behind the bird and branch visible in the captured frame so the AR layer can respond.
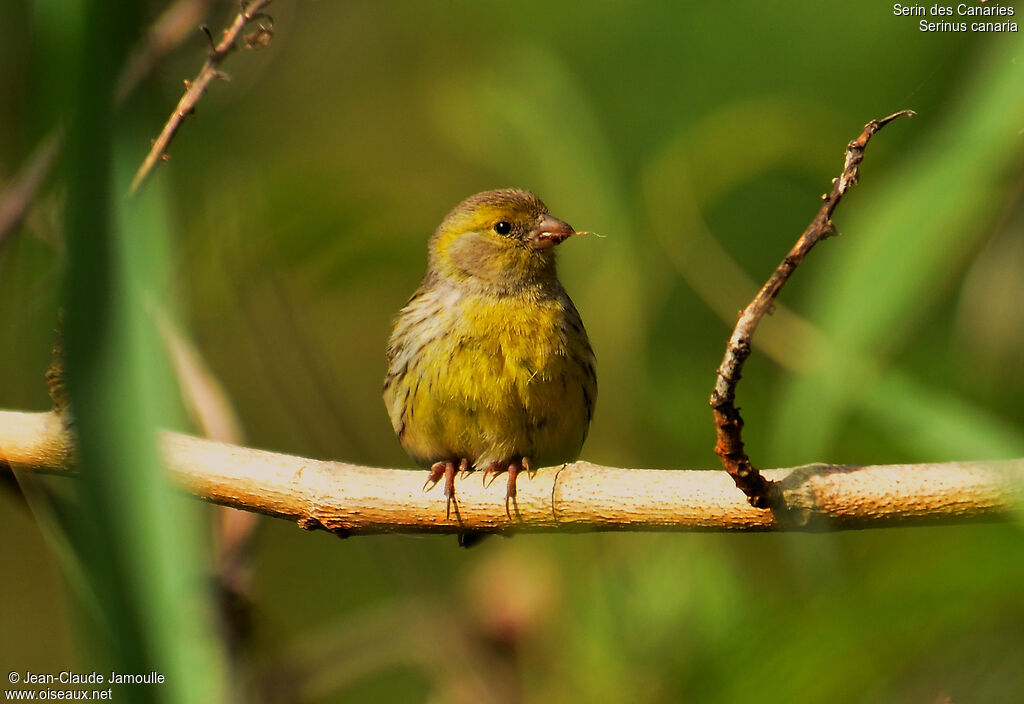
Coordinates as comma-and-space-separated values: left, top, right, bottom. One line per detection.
0, 0, 1024, 704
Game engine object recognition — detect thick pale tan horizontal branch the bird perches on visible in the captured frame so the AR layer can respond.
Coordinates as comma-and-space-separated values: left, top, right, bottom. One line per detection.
0, 411, 1024, 535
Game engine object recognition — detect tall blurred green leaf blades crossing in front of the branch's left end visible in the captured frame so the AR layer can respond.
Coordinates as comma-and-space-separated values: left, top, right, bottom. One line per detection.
4, 2, 224, 702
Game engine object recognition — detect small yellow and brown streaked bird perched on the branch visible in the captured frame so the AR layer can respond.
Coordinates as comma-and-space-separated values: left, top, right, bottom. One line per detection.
383, 188, 597, 520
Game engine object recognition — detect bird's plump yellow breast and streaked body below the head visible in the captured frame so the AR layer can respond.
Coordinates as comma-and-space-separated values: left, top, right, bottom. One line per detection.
385, 280, 596, 461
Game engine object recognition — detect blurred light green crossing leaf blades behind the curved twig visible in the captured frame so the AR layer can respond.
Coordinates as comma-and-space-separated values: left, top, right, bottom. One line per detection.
774, 41, 1024, 461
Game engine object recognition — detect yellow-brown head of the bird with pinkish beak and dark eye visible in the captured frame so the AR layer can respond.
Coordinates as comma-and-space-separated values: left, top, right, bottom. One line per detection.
430, 188, 577, 289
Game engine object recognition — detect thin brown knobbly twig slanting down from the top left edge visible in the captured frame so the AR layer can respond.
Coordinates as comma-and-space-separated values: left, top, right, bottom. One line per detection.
129, 0, 272, 193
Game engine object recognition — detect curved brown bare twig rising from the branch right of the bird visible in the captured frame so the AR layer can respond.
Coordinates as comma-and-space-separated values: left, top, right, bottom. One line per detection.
711, 111, 914, 509
